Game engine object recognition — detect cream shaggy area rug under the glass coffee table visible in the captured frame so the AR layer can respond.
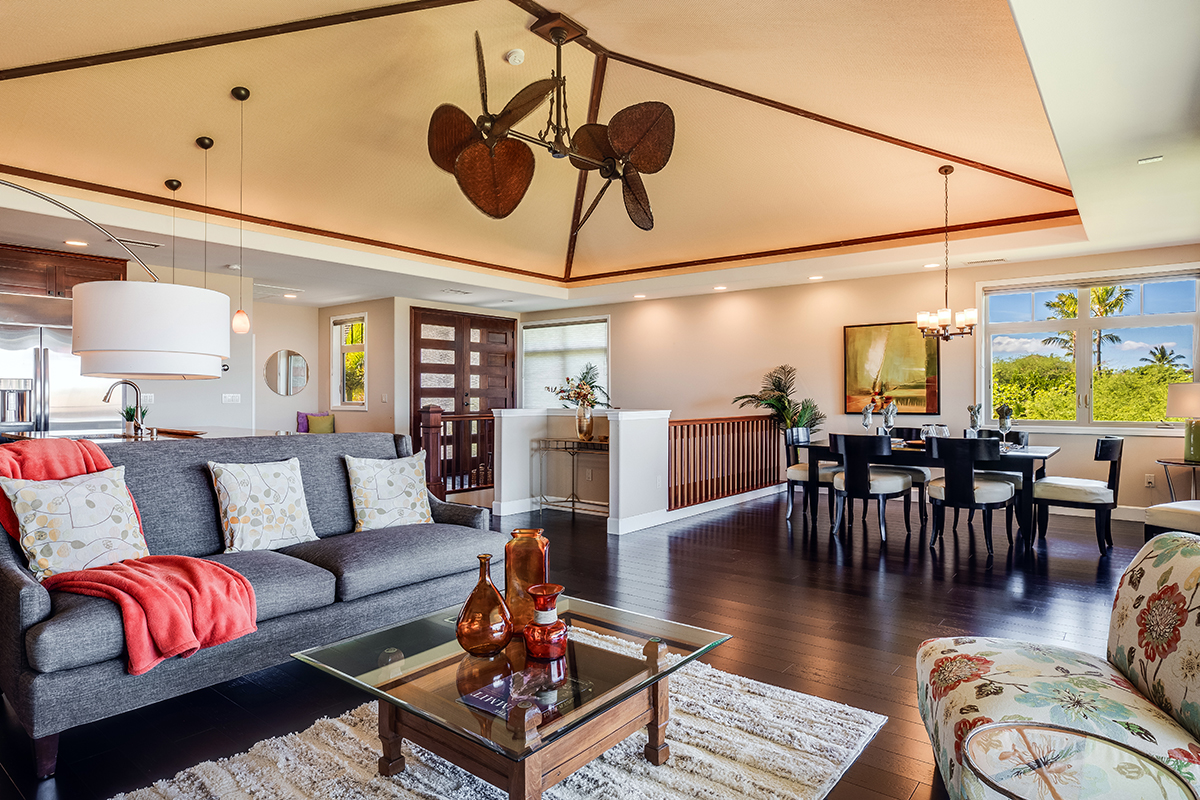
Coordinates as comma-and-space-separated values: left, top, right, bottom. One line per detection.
118, 638, 887, 800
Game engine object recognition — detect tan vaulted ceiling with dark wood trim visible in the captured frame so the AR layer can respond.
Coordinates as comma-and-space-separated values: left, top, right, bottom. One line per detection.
0, 0, 1079, 296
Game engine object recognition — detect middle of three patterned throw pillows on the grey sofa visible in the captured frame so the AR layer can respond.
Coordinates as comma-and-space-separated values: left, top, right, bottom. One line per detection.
209, 458, 317, 553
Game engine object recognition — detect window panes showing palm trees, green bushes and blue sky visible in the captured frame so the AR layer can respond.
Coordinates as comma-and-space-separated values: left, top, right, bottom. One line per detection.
983, 275, 1198, 425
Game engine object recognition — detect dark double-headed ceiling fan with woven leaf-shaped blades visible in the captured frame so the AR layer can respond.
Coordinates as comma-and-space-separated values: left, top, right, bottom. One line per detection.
428, 14, 674, 231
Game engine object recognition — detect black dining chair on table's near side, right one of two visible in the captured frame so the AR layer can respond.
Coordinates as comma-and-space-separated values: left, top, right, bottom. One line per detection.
929, 437, 1016, 555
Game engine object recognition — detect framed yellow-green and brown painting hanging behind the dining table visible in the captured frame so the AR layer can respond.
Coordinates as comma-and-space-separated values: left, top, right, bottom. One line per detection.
844, 323, 941, 414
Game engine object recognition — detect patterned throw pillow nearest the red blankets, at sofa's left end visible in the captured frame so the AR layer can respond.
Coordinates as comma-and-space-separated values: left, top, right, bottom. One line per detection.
0, 467, 150, 581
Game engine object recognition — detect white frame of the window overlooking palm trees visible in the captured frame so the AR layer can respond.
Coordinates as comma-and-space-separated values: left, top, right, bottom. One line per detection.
974, 261, 1200, 437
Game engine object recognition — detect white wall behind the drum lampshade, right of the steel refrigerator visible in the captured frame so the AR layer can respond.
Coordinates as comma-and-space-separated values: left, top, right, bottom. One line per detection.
130, 269, 256, 431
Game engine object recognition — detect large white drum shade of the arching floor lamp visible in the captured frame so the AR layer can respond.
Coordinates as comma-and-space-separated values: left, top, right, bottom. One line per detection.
71, 281, 229, 380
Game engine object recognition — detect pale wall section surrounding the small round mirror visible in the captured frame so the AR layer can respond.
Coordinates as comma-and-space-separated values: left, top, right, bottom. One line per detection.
250, 302, 320, 431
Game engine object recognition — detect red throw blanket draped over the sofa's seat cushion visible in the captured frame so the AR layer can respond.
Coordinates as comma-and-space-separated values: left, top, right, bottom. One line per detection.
42, 555, 258, 675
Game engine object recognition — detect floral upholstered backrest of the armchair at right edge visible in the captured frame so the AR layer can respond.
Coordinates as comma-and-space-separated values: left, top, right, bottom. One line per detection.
1108, 533, 1200, 738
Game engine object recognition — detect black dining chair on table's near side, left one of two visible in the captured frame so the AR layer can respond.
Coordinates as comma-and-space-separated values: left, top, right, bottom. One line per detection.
829, 433, 912, 541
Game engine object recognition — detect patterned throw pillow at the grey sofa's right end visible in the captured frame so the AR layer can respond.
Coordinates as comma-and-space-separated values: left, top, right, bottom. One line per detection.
346, 451, 433, 530
